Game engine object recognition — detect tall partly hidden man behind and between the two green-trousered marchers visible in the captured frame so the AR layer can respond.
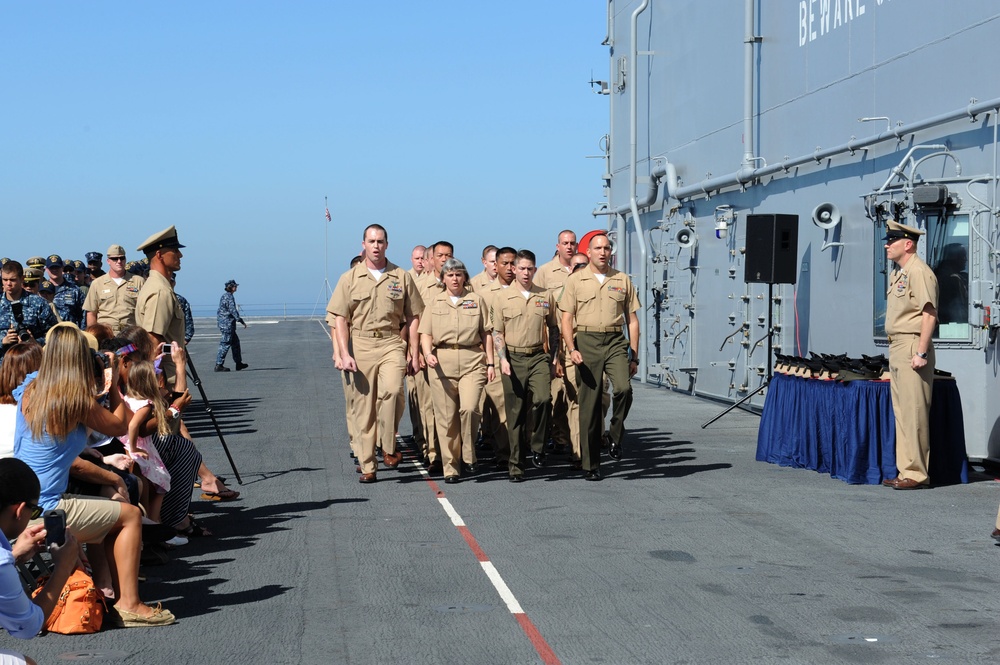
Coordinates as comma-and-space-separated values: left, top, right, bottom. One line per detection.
535, 229, 580, 456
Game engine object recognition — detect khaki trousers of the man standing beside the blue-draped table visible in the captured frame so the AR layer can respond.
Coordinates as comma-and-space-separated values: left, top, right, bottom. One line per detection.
889, 334, 934, 483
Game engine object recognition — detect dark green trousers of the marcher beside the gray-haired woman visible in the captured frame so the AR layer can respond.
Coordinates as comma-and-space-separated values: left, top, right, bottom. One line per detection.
502, 351, 551, 476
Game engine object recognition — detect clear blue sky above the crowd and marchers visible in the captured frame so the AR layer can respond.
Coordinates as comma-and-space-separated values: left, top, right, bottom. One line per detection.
0, 0, 608, 313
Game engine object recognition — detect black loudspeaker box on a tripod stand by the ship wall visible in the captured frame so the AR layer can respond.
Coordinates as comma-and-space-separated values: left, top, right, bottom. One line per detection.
744, 215, 799, 284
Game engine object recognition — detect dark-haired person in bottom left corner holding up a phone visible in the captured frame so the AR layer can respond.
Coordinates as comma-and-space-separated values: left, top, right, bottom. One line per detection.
0, 457, 79, 664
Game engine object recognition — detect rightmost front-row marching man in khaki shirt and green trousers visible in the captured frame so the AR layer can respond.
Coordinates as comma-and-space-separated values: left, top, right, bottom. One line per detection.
559, 235, 639, 480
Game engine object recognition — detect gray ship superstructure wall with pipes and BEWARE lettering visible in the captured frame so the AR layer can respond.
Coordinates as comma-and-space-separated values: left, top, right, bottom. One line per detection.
595, 0, 1000, 458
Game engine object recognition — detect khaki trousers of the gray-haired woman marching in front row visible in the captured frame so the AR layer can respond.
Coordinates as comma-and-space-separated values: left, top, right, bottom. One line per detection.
429, 349, 486, 478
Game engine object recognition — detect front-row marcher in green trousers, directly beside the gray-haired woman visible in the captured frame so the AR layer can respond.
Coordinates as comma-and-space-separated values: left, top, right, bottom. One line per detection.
491, 249, 554, 483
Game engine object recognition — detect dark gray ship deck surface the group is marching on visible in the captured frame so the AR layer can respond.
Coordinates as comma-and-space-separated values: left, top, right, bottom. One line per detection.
11, 321, 1000, 665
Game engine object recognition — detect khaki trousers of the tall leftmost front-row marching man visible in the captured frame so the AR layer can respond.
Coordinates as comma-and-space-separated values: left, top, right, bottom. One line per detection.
351, 336, 406, 473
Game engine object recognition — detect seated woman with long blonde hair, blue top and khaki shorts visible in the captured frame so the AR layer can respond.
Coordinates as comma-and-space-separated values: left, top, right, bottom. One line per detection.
14, 323, 174, 627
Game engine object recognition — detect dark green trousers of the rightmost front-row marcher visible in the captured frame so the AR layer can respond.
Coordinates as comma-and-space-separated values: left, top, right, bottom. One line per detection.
576, 332, 632, 471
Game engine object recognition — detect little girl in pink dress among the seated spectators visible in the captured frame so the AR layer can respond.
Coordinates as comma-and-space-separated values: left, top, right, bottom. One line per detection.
123, 360, 171, 522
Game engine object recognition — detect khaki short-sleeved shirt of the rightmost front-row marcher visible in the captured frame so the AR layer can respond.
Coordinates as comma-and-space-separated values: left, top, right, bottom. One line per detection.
559, 268, 639, 328
